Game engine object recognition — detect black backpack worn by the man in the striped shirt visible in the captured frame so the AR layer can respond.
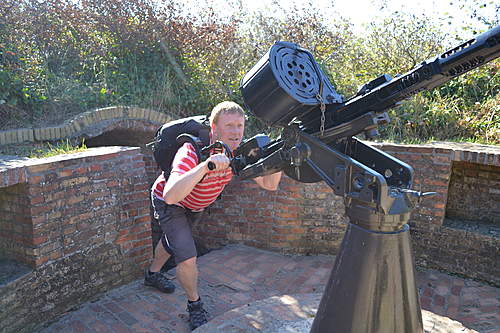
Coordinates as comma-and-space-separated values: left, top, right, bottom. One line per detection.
147, 116, 210, 175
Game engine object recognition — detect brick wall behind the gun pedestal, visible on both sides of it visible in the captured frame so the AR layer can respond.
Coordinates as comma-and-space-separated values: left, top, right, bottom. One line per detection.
195, 144, 500, 285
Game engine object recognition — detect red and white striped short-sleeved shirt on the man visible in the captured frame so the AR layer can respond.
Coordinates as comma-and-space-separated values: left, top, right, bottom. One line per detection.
153, 142, 233, 211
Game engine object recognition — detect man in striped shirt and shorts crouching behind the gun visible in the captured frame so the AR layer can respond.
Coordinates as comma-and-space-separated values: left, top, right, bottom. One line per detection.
144, 102, 281, 330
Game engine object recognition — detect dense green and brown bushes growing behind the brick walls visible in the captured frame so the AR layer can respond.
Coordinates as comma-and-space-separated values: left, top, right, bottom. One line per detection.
0, 0, 500, 144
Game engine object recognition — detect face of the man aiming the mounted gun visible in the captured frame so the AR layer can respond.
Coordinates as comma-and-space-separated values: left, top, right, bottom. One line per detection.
212, 113, 245, 151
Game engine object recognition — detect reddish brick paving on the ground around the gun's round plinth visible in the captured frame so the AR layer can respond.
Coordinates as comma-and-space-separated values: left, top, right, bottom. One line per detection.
37, 245, 500, 333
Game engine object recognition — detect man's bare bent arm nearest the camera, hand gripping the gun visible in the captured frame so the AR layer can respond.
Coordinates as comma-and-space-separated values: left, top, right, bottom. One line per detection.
163, 154, 229, 205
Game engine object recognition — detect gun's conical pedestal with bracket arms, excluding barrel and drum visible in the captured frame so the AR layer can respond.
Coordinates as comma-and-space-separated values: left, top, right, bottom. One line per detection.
284, 131, 431, 333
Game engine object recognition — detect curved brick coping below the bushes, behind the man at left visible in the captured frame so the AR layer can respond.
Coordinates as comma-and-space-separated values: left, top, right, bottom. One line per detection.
0, 106, 172, 146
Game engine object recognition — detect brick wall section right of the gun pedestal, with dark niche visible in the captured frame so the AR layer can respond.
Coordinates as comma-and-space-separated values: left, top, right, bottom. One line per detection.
379, 143, 500, 285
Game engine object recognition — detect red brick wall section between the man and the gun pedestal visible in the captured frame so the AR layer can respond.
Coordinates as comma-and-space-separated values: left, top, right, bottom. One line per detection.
194, 176, 347, 254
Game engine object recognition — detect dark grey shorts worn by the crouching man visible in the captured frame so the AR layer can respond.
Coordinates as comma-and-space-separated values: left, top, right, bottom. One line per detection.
151, 195, 202, 264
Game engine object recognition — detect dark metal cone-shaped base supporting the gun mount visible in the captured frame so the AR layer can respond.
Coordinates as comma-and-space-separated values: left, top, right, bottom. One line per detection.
311, 201, 423, 333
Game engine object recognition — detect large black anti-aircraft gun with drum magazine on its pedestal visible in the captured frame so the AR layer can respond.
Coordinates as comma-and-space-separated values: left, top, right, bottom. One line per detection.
232, 27, 500, 333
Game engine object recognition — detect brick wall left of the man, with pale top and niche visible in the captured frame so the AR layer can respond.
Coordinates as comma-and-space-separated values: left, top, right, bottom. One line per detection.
0, 147, 152, 332
